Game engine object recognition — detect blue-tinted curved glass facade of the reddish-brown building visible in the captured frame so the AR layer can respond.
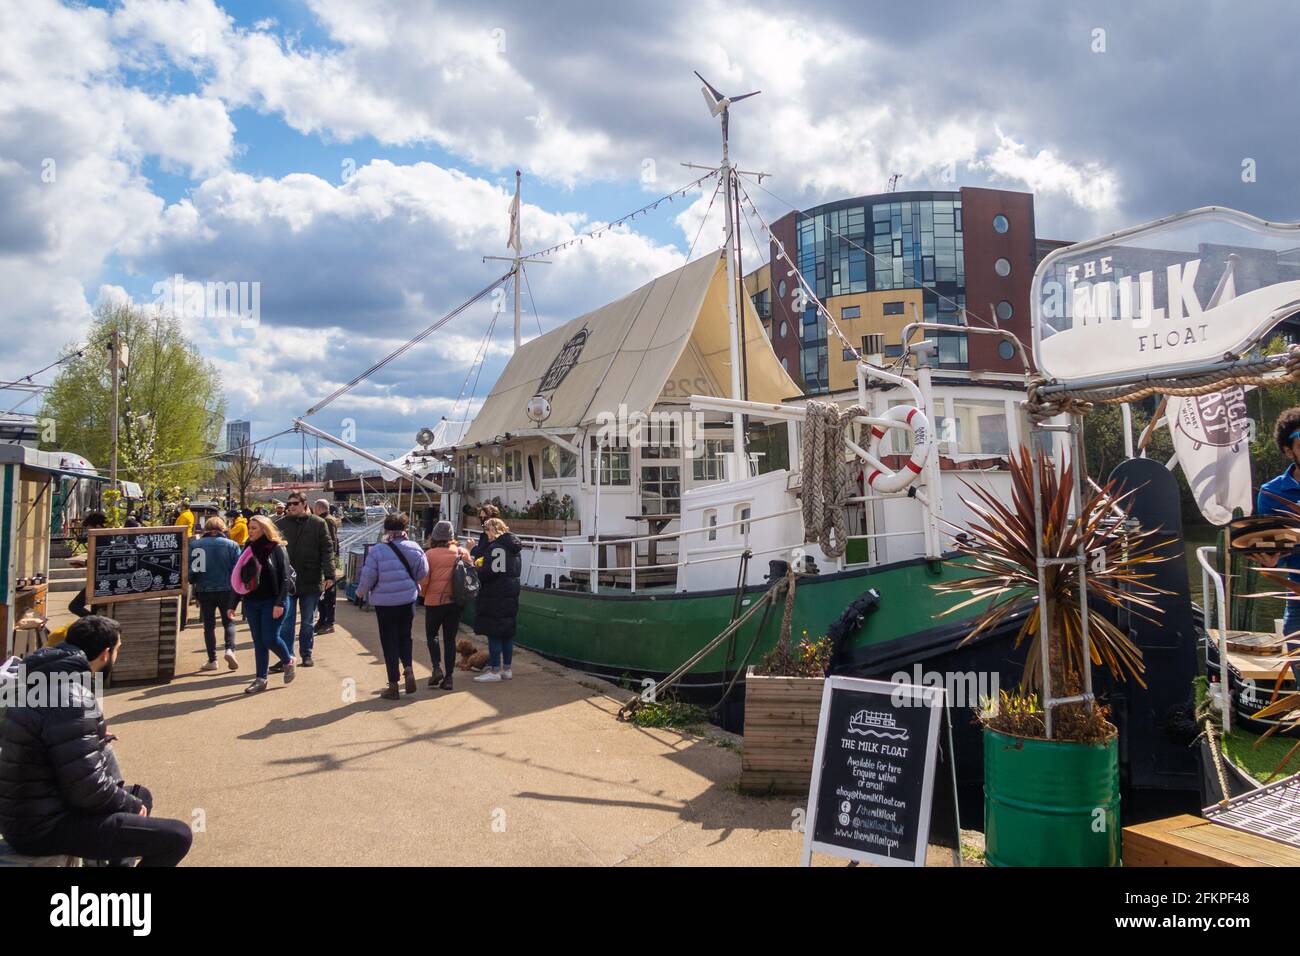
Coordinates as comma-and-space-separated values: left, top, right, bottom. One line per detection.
776, 193, 967, 392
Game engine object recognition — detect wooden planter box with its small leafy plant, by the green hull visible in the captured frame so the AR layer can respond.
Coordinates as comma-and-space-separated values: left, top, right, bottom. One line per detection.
740, 631, 831, 793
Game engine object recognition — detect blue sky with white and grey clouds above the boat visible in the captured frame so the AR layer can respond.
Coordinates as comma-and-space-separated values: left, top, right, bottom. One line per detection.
0, 0, 1300, 464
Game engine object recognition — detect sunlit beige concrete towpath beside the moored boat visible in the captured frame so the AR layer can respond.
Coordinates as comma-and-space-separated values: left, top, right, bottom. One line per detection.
76, 601, 967, 866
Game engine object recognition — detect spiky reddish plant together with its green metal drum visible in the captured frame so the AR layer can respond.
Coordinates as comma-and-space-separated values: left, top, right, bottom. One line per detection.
932, 447, 1170, 866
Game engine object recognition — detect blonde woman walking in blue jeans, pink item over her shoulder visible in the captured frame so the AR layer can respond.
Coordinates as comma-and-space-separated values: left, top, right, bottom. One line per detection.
237, 515, 296, 693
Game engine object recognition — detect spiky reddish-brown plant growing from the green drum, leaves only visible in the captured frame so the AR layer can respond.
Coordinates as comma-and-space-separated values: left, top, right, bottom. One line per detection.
933, 446, 1170, 738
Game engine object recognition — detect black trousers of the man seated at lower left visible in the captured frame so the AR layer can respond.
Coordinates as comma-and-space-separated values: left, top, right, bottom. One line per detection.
13, 786, 194, 866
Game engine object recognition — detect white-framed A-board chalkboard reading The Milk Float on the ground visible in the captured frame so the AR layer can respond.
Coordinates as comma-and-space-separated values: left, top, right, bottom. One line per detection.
803, 678, 945, 866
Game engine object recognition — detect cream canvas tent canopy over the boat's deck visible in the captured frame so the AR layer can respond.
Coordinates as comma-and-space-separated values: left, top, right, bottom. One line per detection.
460, 250, 800, 447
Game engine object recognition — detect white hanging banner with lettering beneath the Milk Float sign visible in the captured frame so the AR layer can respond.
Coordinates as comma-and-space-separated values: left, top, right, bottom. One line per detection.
1167, 385, 1255, 524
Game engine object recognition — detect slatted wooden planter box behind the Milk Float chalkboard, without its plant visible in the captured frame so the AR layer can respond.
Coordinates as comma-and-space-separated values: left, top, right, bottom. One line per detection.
740, 667, 826, 795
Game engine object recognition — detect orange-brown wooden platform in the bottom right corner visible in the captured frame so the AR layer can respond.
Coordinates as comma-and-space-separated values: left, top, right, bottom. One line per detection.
1123, 814, 1300, 866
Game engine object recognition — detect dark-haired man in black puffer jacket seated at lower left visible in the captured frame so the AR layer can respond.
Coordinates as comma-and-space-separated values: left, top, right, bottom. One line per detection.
0, 614, 192, 866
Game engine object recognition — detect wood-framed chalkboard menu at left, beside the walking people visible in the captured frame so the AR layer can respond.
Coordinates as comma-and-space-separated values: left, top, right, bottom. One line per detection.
86, 525, 190, 604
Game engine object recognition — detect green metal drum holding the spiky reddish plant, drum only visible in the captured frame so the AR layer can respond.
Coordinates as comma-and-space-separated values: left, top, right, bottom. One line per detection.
984, 727, 1121, 866
